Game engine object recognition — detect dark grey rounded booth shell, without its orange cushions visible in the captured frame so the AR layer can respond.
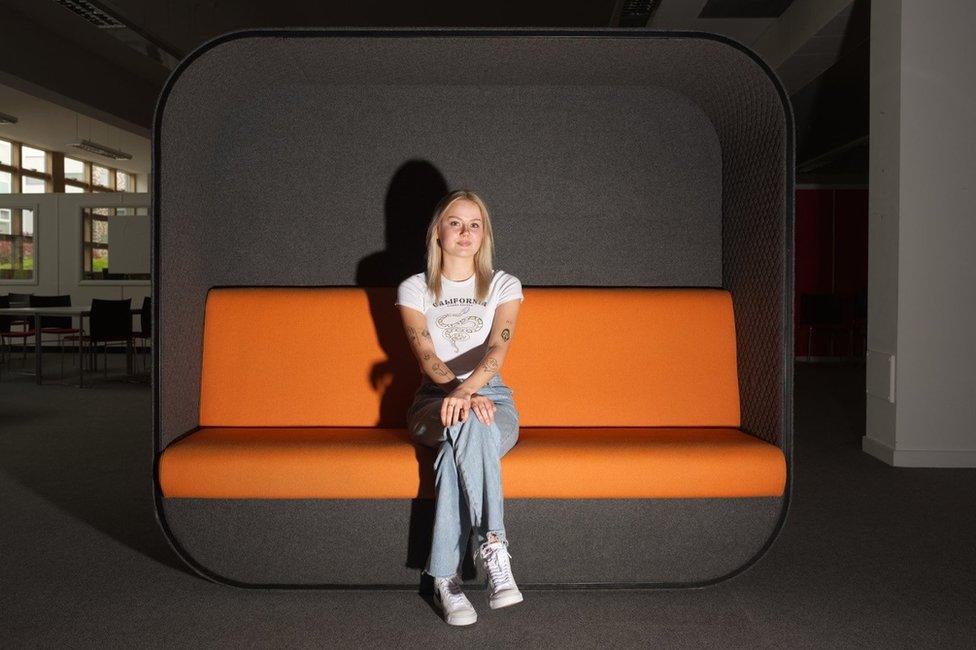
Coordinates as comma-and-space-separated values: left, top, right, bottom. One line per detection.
152, 29, 794, 588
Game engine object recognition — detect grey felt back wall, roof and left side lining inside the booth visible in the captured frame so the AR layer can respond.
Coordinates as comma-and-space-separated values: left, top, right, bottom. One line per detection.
155, 38, 748, 445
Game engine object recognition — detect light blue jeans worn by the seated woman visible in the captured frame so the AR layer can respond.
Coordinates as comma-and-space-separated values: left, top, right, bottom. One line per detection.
407, 374, 519, 576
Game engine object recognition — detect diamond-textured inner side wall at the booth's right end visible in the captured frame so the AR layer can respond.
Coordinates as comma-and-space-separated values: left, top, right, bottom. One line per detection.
680, 43, 793, 449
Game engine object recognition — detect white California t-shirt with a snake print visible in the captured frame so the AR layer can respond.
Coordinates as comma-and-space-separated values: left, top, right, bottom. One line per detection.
395, 269, 524, 381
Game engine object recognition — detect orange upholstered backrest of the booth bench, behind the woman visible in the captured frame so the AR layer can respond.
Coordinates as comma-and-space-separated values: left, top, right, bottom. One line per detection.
200, 287, 740, 428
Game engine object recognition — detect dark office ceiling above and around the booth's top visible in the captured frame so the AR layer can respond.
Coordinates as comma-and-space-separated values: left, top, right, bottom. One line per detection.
0, 0, 870, 178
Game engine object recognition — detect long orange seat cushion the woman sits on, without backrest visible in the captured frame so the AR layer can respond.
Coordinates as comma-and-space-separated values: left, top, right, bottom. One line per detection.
159, 427, 786, 499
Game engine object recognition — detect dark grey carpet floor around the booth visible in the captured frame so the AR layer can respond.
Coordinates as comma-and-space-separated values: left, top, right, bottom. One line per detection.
0, 355, 976, 648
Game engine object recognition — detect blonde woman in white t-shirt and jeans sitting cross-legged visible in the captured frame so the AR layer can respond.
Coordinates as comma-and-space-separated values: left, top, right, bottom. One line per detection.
396, 190, 522, 625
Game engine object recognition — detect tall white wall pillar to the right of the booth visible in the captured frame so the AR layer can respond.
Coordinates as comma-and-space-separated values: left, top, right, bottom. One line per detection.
863, 0, 976, 467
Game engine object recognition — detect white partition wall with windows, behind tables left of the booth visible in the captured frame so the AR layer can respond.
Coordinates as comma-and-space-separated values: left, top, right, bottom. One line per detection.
0, 192, 151, 345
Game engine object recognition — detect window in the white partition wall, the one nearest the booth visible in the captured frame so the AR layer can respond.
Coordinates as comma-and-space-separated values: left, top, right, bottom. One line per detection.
81, 207, 150, 280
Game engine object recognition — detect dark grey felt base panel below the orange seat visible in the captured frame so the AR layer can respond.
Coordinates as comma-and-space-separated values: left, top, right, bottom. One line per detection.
163, 498, 782, 586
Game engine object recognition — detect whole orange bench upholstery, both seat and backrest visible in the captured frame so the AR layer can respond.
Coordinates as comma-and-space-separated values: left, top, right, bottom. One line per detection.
160, 287, 786, 499
